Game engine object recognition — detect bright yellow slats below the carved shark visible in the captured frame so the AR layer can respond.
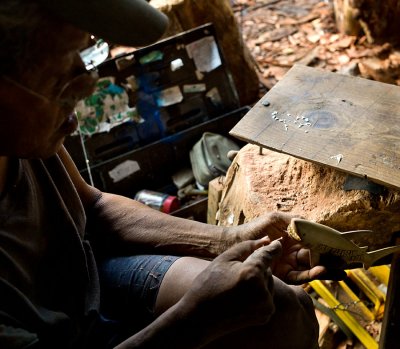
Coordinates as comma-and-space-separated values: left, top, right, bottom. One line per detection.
309, 265, 390, 349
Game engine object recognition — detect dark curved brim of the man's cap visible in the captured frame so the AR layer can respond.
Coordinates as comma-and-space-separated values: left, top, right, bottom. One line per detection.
40, 0, 168, 47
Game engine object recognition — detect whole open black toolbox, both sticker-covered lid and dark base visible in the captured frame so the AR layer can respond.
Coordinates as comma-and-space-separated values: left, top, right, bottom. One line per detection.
65, 24, 245, 197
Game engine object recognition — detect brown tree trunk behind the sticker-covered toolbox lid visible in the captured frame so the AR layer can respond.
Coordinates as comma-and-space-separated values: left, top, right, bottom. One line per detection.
150, 0, 259, 105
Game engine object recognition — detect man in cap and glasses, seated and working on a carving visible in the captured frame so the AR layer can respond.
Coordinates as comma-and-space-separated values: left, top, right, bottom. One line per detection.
0, 0, 338, 349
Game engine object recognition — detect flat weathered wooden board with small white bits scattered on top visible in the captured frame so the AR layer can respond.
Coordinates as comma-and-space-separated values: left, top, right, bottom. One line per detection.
230, 65, 400, 188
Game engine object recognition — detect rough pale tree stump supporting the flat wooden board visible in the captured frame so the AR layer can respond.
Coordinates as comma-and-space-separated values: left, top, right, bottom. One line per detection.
219, 144, 400, 249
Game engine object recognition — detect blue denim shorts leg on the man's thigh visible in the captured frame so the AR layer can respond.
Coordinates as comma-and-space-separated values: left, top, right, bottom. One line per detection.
90, 255, 179, 348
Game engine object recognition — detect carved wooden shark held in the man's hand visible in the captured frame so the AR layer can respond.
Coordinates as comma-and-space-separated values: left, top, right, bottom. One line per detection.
287, 218, 400, 269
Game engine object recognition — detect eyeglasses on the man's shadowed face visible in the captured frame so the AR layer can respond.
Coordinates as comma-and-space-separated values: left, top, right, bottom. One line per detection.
2, 67, 99, 108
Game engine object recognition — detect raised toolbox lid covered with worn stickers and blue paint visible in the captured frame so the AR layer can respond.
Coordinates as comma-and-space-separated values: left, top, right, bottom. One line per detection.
65, 24, 239, 170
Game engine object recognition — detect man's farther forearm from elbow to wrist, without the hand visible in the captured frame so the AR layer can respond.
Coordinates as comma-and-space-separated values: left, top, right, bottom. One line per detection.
88, 193, 237, 258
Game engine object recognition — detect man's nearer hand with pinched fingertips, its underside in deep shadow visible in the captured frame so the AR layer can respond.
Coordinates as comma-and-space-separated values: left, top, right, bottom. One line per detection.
183, 239, 282, 337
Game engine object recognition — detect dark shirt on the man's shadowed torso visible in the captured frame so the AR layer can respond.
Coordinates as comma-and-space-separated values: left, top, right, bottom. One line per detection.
0, 156, 99, 349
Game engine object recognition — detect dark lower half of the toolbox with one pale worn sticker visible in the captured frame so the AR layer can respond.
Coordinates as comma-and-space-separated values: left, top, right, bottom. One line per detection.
81, 107, 249, 197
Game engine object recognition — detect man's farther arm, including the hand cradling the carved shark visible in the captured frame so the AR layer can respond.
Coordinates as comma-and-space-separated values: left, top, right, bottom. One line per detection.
59, 145, 334, 284
